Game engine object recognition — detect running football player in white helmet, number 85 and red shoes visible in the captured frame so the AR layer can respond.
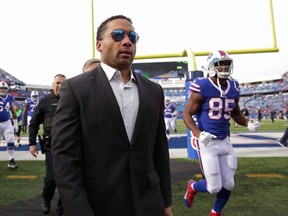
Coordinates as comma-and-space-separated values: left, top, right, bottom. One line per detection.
183, 50, 260, 216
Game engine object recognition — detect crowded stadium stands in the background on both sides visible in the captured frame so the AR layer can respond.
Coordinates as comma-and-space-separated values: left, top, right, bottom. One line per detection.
0, 68, 288, 120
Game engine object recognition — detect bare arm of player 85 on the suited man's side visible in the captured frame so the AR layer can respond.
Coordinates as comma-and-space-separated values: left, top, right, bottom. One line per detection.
183, 92, 204, 138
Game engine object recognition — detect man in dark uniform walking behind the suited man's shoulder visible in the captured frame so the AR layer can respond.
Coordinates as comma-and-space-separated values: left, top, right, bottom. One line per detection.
29, 74, 66, 216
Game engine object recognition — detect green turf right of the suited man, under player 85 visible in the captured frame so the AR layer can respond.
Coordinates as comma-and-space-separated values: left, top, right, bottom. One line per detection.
173, 158, 288, 216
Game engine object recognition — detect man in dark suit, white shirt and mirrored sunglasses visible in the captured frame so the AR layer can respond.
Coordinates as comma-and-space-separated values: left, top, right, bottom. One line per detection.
52, 15, 172, 216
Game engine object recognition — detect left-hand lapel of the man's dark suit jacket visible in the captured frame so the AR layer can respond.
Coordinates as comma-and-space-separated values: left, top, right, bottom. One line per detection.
91, 67, 130, 143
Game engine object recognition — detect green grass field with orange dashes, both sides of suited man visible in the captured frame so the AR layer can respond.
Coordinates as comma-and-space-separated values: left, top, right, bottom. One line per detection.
0, 158, 288, 216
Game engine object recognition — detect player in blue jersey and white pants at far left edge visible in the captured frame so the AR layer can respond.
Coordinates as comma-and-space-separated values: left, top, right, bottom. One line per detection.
0, 80, 18, 169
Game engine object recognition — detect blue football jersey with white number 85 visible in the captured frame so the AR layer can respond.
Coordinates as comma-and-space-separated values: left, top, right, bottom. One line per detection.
189, 77, 240, 139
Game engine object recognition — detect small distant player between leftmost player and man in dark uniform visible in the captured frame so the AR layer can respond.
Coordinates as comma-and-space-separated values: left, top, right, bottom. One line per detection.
22, 91, 39, 126
